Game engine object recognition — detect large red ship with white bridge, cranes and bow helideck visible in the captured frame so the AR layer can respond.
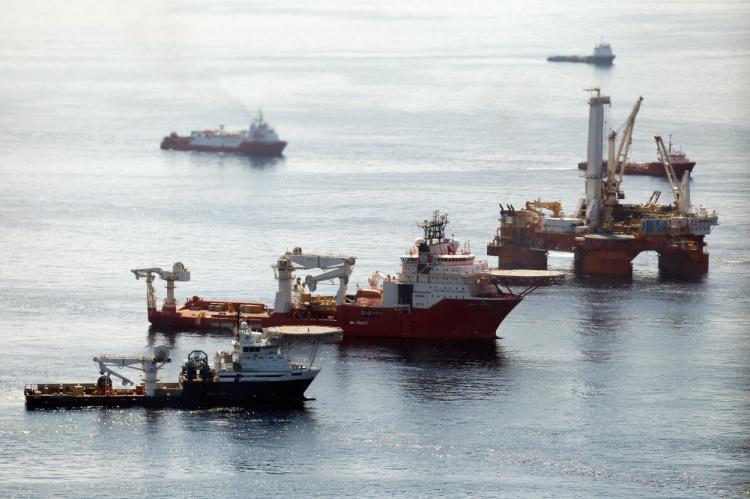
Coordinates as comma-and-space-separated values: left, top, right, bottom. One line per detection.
133, 212, 561, 339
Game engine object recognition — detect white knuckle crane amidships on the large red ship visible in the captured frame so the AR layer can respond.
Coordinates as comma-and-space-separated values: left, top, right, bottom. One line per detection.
273, 248, 356, 313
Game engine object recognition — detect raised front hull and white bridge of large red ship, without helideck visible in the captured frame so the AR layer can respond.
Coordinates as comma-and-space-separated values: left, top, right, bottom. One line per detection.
336, 212, 536, 339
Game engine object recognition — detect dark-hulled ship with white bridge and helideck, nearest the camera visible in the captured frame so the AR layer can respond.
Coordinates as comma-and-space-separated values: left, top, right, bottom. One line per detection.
24, 322, 341, 409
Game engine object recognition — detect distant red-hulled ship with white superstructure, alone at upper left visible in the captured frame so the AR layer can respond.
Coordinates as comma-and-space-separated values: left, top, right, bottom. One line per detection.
161, 112, 286, 156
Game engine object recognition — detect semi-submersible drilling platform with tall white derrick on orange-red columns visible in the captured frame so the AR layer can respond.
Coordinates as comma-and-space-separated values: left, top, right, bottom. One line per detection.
487, 88, 718, 279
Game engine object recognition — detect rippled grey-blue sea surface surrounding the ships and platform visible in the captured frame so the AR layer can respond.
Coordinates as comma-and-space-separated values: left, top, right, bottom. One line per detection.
0, 0, 750, 497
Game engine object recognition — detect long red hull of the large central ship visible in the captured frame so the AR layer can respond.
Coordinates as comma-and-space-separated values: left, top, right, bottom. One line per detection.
148, 295, 523, 339
